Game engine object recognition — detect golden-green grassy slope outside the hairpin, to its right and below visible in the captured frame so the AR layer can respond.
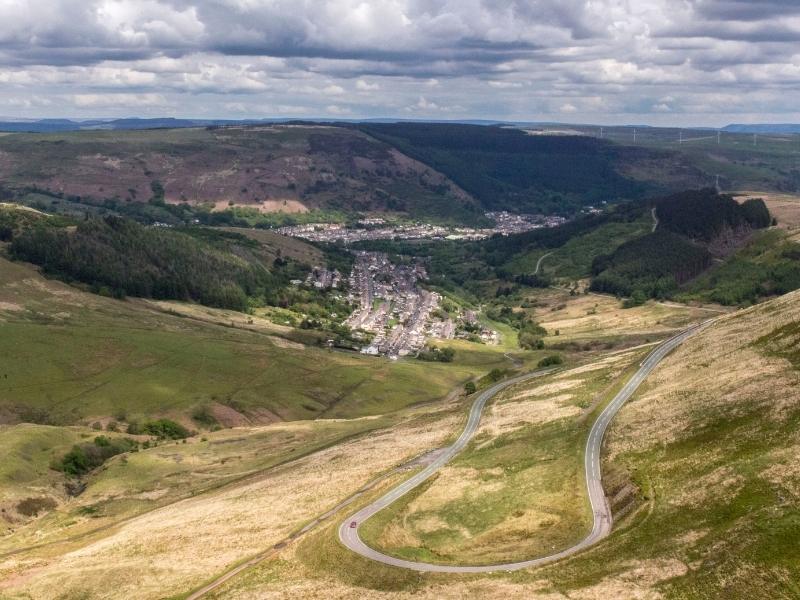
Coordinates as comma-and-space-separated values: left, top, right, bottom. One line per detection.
198, 292, 800, 600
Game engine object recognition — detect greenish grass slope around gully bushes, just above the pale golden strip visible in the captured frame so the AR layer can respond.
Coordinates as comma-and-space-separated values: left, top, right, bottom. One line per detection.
0, 418, 390, 553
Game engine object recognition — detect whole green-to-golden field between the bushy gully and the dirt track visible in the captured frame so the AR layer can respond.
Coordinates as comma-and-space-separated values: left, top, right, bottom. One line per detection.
0, 396, 468, 598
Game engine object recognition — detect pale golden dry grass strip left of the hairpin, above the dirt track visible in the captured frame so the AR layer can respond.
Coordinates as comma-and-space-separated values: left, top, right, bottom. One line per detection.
0, 417, 456, 598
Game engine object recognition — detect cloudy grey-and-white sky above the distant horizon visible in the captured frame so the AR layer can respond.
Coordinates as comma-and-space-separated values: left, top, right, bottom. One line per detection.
0, 0, 800, 126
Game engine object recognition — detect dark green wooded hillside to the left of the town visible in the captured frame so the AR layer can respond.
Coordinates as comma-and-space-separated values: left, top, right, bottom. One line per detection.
10, 216, 301, 311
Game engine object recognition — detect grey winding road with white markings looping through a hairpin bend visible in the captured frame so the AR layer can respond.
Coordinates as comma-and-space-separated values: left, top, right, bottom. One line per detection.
339, 320, 711, 573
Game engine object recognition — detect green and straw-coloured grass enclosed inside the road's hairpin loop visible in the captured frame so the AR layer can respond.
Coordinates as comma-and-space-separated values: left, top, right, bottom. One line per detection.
363, 349, 643, 564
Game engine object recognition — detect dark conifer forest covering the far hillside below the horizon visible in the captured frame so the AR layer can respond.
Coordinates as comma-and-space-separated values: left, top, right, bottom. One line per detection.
357, 123, 655, 215
